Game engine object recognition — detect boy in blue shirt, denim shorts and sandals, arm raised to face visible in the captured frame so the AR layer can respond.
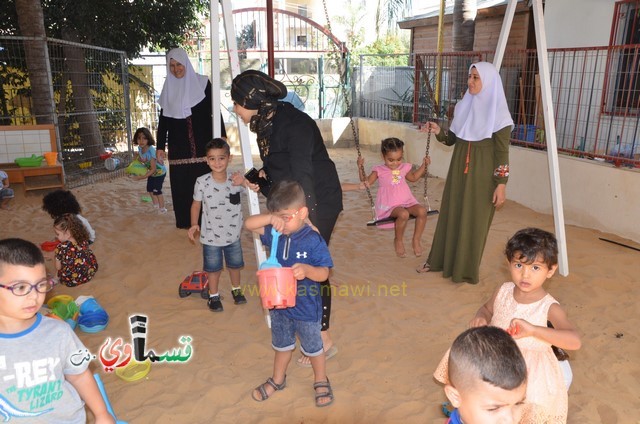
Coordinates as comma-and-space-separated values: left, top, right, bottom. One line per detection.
245, 180, 333, 407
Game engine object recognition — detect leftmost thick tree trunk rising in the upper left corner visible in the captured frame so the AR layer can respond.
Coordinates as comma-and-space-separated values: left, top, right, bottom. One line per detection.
16, 0, 54, 124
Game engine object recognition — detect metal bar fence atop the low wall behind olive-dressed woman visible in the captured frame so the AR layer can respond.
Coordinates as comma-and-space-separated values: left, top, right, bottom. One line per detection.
353, 50, 640, 167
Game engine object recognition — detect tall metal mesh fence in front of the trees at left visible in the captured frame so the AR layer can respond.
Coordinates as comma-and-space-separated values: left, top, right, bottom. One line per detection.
0, 36, 156, 188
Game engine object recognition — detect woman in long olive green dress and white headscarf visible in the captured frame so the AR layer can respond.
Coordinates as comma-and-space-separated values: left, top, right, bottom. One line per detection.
417, 62, 513, 284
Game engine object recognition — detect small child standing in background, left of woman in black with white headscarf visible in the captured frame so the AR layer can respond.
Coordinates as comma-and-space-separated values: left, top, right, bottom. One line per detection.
131, 127, 167, 214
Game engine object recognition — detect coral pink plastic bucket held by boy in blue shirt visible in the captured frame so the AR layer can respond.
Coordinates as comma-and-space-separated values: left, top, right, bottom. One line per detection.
256, 268, 298, 309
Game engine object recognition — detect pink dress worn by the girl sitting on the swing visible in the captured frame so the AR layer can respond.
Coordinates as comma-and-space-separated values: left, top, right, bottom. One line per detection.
373, 163, 419, 226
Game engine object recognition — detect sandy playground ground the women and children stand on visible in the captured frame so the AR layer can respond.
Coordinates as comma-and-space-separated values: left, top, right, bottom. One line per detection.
0, 149, 640, 424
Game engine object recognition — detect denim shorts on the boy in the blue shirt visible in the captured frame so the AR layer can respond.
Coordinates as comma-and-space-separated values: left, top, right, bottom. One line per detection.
269, 309, 324, 356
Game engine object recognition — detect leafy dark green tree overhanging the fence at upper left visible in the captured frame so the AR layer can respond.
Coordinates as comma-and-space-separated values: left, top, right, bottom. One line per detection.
0, 0, 209, 156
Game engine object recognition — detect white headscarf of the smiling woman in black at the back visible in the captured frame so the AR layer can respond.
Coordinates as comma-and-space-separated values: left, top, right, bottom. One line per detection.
158, 48, 209, 119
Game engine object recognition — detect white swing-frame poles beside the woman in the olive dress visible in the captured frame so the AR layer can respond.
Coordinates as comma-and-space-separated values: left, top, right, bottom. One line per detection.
493, 0, 569, 277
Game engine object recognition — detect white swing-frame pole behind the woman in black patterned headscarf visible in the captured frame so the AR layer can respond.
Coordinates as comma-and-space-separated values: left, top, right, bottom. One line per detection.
215, 0, 271, 327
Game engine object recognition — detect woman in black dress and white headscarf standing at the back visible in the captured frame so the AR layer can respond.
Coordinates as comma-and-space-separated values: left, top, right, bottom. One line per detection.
156, 48, 227, 229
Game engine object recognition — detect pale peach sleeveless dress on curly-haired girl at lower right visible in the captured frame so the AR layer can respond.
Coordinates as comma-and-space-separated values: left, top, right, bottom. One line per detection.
433, 283, 569, 424
